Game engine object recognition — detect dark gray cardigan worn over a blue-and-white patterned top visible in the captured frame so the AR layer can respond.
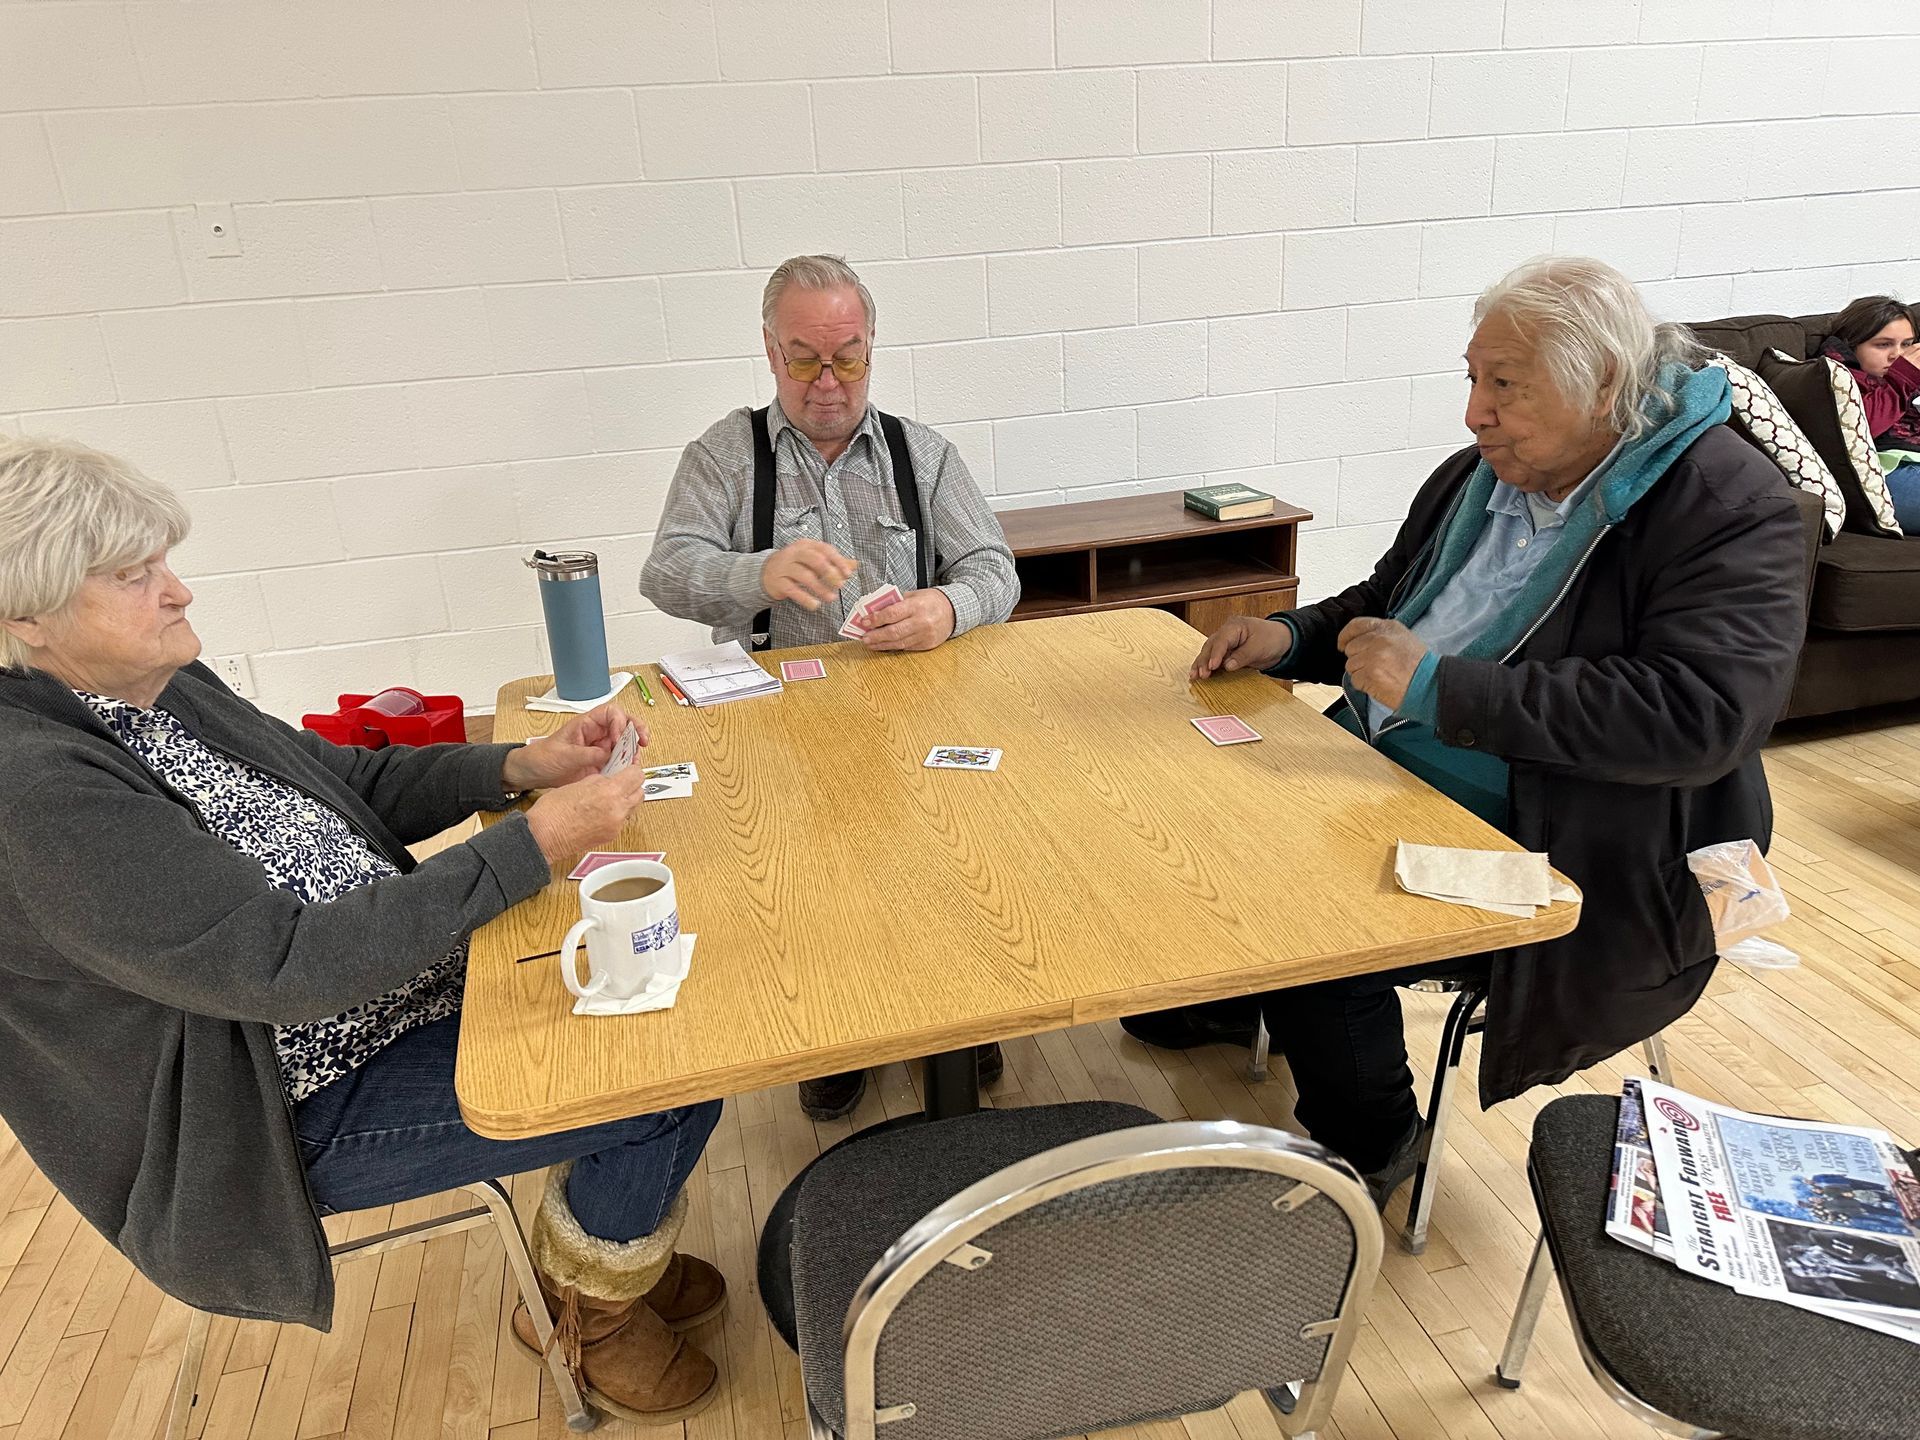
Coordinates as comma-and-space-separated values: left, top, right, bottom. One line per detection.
0, 664, 551, 1329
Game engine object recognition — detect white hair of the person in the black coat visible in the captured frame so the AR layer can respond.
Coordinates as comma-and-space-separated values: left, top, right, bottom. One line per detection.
1473, 255, 1705, 440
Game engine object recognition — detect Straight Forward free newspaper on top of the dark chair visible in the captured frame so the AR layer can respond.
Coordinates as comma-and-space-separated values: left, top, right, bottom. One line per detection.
1635, 1079, 1920, 1344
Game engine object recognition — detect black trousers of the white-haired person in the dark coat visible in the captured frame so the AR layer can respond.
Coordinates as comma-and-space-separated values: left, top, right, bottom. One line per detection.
1260, 960, 1486, 1175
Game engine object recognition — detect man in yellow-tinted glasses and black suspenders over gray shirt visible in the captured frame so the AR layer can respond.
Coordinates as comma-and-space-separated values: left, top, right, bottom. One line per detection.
639, 255, 1020, 1119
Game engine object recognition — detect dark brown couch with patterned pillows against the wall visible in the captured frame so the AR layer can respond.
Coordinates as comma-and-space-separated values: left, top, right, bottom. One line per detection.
1692, 315, 1920, 720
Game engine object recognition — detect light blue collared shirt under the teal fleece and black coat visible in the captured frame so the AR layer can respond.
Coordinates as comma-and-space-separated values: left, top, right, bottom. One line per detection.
1367, 442, 1624, 735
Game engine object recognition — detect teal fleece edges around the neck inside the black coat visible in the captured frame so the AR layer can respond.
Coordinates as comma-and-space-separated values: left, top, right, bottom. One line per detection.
1392, 363, 1734, 660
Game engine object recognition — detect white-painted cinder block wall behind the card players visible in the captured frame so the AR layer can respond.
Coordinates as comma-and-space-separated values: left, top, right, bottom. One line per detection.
0, 0, 1920, 716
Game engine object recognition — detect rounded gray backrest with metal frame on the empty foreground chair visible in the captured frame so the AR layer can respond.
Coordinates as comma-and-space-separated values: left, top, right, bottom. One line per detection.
843, 1121, 1380, 1440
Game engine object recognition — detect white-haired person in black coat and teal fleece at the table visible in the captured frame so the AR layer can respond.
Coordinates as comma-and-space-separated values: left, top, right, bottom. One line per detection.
1192, 259, 1805, 1206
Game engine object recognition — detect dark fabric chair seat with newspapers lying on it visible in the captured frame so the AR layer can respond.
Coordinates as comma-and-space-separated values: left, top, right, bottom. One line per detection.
1526, 1094, 1920, 1440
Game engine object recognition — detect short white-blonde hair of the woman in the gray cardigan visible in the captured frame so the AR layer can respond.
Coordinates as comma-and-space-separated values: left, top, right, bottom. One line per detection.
0, 438, 192, 668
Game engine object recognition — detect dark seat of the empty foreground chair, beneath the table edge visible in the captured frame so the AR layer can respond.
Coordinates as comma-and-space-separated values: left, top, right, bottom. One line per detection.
791, 1100, 1160, 1432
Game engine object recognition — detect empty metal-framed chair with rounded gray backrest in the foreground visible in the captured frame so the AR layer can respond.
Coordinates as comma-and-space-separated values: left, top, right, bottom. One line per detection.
791, 1102, 1382, 1440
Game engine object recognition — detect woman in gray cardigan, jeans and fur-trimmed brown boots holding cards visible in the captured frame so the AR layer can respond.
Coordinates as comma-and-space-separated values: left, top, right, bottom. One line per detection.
0, 442, 726, 1421
